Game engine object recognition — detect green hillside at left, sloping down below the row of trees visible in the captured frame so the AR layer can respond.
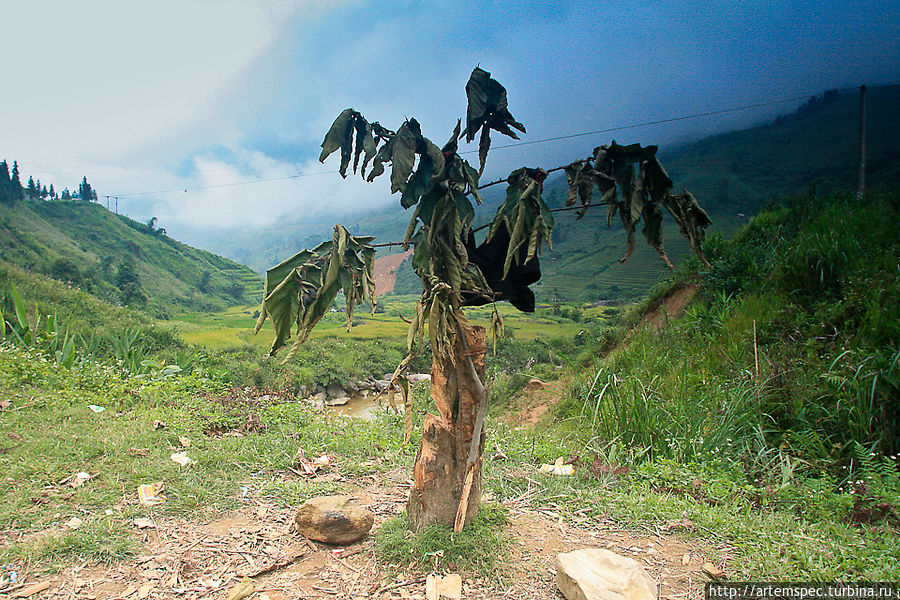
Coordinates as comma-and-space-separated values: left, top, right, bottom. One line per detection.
0, 200, 262, 317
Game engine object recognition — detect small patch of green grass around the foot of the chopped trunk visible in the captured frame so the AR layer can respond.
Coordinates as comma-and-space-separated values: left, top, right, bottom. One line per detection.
375, 503, 509, 576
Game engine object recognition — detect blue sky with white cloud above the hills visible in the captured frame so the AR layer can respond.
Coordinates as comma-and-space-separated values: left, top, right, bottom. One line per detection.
0, 0, 900, 235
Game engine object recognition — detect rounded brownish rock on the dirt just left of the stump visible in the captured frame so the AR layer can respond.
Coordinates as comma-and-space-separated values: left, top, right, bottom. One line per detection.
294, 496, 375, 546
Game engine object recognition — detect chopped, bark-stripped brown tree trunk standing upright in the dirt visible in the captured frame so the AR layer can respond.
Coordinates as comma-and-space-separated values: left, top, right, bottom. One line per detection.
407, 326, 486, 532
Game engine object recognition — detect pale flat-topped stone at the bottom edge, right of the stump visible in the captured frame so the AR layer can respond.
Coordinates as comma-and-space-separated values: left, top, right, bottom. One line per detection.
556, 548, 656, 600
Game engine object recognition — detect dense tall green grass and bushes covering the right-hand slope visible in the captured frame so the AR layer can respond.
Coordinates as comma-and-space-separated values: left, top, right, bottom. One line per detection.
561, 195, 900, 465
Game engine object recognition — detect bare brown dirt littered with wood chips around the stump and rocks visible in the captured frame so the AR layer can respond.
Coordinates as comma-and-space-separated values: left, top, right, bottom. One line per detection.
0, 464, 727, 600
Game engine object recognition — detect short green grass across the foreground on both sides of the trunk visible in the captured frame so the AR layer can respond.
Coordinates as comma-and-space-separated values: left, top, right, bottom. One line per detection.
0, 345, 900, 581
